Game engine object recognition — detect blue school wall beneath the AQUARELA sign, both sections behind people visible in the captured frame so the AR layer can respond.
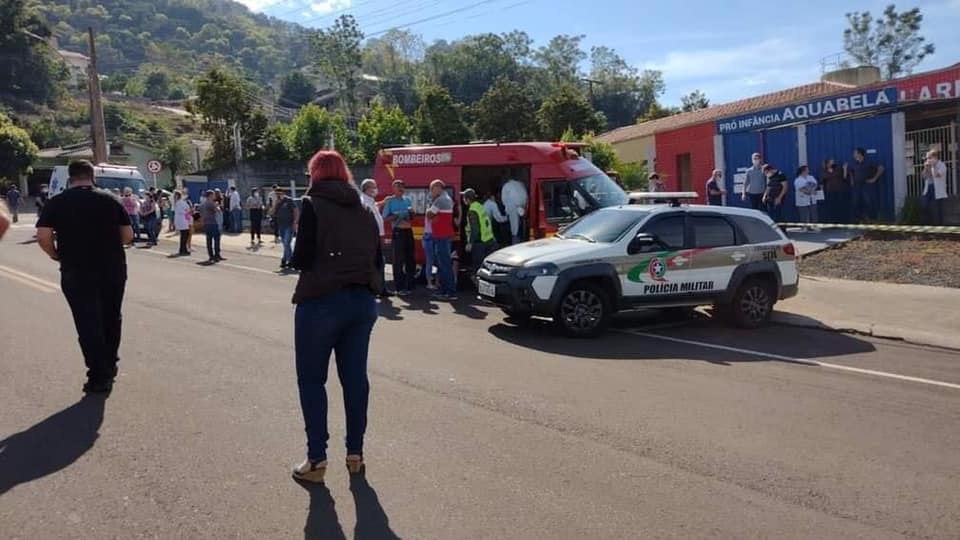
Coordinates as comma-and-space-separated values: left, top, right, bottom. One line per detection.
723, 114, 895, 221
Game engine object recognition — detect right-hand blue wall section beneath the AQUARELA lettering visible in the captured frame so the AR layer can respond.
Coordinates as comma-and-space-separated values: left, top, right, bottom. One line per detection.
807, 114, 896, 221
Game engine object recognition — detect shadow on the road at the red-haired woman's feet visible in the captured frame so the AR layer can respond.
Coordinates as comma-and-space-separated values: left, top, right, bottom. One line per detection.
297, 474, 401, 540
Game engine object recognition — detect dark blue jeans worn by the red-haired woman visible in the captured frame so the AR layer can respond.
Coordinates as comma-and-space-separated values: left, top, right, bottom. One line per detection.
294, 288, 377, 461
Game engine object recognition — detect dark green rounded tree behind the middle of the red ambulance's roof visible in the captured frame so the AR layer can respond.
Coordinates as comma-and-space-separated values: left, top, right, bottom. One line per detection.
474, 77, 537, 141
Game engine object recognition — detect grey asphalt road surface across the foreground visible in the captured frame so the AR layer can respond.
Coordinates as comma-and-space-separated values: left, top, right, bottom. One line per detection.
0, 221, 960, 540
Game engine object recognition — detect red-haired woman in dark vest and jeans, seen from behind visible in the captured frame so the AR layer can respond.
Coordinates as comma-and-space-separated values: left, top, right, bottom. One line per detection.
291, 150, 381, 482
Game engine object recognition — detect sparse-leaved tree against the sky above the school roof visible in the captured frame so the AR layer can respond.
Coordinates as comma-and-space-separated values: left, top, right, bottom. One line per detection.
843, 4, 935, 79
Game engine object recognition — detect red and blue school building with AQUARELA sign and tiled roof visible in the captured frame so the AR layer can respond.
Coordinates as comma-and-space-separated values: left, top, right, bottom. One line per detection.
598, 64, 960, 224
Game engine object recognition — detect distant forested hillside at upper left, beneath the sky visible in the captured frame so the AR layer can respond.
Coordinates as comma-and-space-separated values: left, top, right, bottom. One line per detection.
31, 0, 310, 82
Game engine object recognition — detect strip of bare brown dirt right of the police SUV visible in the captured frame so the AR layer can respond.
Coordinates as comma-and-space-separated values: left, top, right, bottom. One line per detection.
800, 233, 960, 288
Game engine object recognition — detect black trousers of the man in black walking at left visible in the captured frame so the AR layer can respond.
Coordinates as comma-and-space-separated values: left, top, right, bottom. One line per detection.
60, 266, 127, 382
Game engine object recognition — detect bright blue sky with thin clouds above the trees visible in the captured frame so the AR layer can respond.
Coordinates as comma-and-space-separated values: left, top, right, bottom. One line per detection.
239, 0, 960, 105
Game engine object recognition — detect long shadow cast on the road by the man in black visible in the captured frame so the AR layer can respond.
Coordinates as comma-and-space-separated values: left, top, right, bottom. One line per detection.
0, 395, 106, 495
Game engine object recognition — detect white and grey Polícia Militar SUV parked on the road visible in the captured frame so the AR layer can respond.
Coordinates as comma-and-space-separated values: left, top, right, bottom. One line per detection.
477, 193, 799, 337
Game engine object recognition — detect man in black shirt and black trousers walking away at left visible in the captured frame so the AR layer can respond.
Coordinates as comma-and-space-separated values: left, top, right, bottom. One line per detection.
37, 161, 133, 393
